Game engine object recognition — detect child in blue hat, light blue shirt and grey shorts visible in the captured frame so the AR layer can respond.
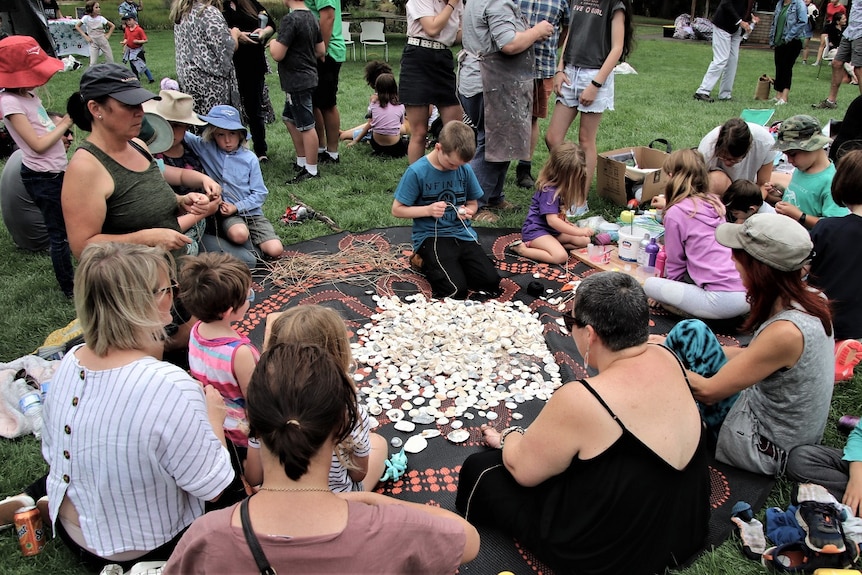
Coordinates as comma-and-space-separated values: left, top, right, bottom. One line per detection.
184, 105, 284, 258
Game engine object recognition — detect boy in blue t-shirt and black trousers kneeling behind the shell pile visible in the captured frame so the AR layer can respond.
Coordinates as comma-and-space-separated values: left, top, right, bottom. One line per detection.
392, 122, 500, 299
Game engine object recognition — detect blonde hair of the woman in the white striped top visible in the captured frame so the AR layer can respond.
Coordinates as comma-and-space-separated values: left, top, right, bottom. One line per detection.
75, 242, 174, 357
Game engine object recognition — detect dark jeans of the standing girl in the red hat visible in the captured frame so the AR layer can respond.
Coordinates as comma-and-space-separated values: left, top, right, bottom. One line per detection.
21, 166, 75, 297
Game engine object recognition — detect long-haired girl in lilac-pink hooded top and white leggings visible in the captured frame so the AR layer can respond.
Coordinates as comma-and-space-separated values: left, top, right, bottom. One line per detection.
644, 149, 749, 319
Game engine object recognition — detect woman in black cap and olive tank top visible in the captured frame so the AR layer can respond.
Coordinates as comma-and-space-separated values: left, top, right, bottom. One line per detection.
62, 64, 221, 349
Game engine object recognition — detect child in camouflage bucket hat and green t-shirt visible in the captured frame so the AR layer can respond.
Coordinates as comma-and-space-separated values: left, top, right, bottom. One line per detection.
775, 114, 848, 230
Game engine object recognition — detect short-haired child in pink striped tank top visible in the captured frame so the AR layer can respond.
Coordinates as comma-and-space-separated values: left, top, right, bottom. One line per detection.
180, 252, 263, 506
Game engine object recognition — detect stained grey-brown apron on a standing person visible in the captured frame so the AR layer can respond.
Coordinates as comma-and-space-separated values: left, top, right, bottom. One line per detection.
479, 46, 535, 162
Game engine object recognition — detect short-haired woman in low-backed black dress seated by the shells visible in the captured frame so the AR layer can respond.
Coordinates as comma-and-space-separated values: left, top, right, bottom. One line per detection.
456, 272, 709, 575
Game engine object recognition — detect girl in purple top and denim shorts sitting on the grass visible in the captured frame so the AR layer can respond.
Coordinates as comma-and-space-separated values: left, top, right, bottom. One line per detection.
508, 142, 593, 264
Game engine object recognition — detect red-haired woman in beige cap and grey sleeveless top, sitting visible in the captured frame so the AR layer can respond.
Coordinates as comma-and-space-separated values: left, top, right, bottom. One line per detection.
665, 214, 835, 476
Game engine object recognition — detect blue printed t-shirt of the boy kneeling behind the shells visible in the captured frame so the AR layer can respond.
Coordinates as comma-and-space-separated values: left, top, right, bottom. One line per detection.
395, 156, 482, 250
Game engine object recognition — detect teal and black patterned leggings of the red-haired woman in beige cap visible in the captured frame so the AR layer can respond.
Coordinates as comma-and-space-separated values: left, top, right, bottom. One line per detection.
664, 319, 739, 438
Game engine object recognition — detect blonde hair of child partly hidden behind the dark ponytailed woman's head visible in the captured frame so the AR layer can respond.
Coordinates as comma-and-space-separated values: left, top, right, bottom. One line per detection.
267, 305, 358, 469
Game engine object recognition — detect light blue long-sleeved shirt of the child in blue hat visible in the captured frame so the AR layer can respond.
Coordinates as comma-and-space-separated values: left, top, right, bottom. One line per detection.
184, 132, 269, 216
